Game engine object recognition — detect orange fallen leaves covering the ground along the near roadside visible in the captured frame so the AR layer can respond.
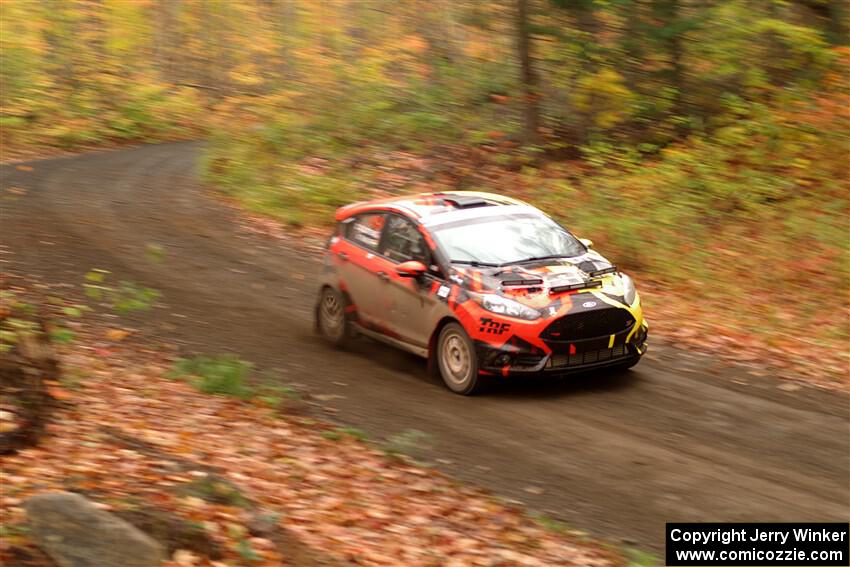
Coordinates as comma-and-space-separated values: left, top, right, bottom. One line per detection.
0, 280, 621, 567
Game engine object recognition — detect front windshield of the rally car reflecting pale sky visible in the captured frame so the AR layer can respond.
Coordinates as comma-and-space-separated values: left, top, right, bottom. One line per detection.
432, 214, 586, 265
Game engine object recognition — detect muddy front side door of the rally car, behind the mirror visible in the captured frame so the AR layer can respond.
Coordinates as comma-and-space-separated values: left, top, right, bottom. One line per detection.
381, 214, 437, 347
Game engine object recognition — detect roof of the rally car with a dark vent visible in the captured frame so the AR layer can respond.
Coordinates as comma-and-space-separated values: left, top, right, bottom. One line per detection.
336, 191, 526, 224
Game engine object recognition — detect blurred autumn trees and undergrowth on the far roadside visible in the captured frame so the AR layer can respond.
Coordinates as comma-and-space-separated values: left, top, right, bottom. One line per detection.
0, 0, 850, 385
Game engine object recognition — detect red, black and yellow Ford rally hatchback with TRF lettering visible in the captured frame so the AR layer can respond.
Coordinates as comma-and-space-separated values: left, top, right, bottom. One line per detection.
316, 192, 648, 394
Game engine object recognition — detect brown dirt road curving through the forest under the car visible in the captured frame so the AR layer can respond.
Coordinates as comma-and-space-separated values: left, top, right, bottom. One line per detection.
0, 143, 850, 551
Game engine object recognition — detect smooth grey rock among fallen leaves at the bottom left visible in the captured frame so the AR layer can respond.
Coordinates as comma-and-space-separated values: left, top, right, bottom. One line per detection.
24, 492, 164, 567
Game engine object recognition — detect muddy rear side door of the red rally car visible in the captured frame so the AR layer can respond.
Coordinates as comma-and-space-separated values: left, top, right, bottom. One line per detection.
334, 213, 386, 328
